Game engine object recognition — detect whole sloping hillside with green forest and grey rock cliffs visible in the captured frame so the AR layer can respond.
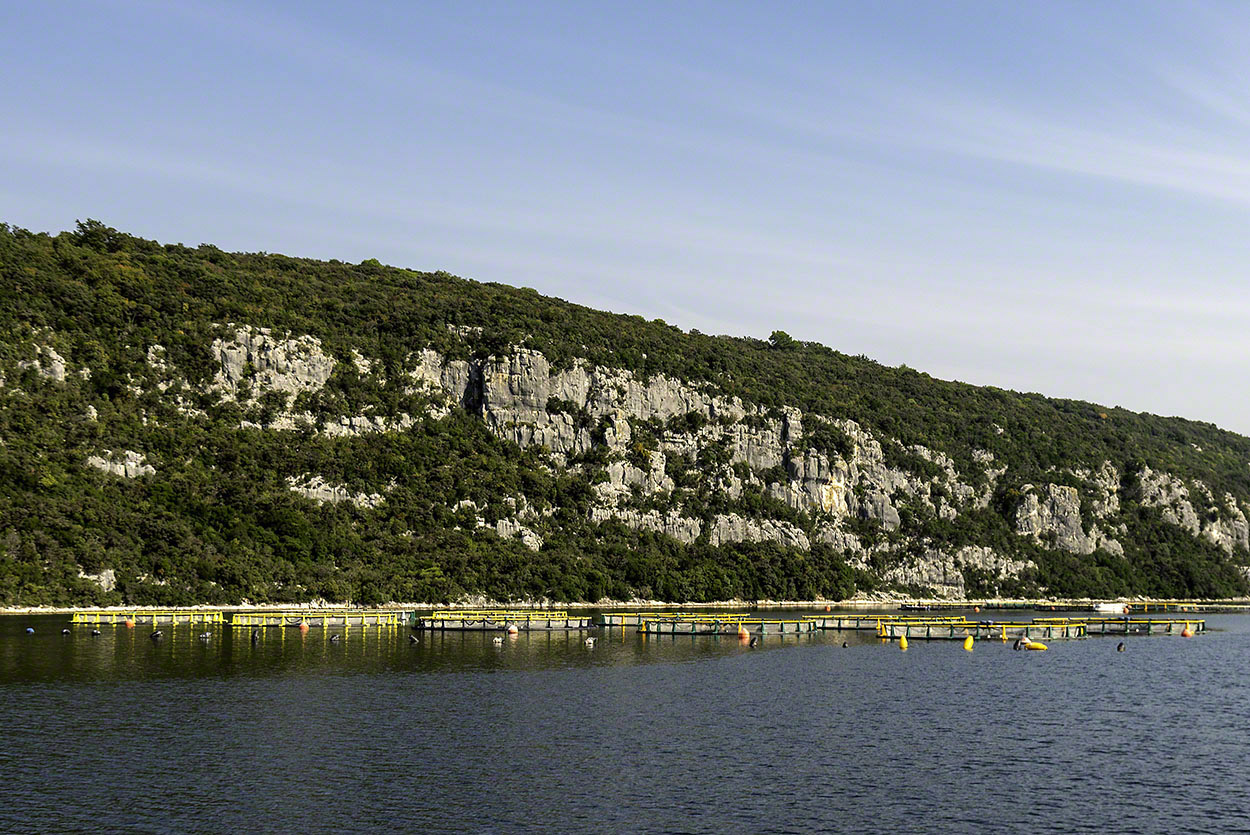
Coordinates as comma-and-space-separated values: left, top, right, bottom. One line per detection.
0, 221, 1250, 605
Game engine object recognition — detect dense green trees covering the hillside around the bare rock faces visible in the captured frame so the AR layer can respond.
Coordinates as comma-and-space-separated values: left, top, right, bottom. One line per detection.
0, 220, 1250, 605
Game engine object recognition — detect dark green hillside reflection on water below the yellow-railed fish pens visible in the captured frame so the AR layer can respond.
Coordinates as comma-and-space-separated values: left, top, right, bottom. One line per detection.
0, 616, 879, 684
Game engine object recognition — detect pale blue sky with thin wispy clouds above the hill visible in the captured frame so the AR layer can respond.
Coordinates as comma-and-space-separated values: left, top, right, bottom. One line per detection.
0, 0, 1250, 435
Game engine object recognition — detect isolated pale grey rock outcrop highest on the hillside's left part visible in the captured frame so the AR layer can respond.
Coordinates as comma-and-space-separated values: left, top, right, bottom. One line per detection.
213, 325, 338, 403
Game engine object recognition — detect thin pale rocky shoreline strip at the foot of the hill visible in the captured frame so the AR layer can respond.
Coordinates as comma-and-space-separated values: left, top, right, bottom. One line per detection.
0, 598, 1250, 615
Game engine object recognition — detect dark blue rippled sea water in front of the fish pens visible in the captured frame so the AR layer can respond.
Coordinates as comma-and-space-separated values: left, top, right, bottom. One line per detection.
0, 613, 1250, 833
